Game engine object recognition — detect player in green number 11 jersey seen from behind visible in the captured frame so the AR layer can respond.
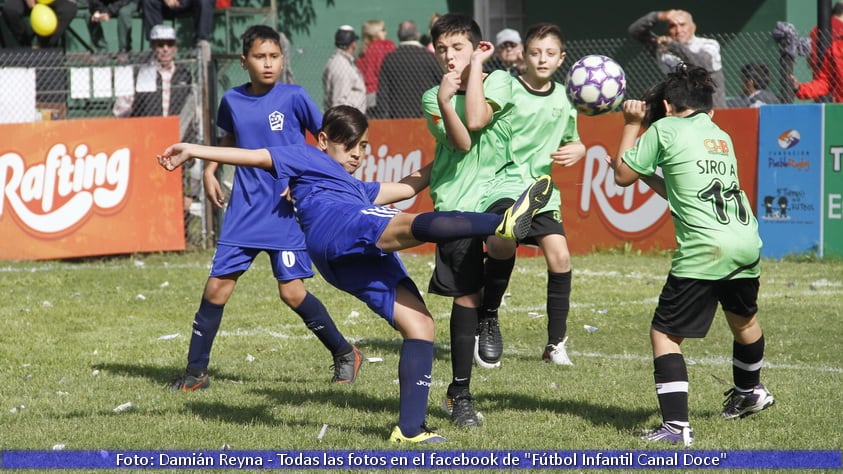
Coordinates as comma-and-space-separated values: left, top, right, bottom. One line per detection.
611, 64, 774, 446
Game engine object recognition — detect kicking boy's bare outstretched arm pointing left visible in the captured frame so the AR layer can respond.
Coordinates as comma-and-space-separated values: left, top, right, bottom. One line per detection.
158, 143, 273, 171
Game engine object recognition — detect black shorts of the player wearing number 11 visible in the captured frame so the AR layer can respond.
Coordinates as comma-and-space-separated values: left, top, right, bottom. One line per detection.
652, 274, 759, 338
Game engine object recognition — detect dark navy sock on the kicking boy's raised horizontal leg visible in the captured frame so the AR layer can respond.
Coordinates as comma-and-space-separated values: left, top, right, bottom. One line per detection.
410, 211, 503, 243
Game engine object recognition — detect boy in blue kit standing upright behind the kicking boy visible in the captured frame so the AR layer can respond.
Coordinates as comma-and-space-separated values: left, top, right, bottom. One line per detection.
171, 25, 363, 391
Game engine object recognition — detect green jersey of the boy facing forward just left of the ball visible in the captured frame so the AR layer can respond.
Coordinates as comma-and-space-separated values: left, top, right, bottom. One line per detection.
484, 78, 580, 216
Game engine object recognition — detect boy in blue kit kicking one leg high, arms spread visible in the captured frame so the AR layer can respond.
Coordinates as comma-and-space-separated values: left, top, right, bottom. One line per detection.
158, 106, 551, 443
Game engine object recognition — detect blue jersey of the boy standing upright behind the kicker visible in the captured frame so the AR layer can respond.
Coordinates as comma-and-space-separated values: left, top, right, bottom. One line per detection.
217, 84, 322, 250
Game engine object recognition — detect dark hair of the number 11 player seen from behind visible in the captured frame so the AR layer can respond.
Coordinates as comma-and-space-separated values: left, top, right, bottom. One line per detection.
643, 63, 715, 127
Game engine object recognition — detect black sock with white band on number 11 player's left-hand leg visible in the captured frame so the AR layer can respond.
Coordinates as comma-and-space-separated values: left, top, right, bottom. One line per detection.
653, 353, 688, 429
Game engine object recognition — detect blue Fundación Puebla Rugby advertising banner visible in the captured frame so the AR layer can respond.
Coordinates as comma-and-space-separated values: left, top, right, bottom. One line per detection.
755, 104, 823, 258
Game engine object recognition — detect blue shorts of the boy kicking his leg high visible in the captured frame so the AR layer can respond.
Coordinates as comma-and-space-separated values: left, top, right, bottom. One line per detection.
305, 201, 421, 327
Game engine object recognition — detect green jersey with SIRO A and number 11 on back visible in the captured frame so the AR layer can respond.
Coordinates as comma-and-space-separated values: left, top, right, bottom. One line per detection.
623, 113, 761, 280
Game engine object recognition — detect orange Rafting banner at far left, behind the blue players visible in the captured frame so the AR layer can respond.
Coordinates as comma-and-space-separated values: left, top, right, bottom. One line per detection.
0, 117, 185, 260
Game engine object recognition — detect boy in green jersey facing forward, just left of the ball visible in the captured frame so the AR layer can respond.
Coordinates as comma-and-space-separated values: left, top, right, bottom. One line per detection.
475, 23, 585, 367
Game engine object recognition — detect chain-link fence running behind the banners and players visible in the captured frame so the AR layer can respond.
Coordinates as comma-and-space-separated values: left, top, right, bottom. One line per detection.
0, 28, 843, 252
